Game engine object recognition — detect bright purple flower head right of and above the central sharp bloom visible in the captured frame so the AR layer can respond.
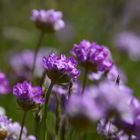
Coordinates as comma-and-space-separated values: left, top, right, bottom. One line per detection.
72, 40, 112, 72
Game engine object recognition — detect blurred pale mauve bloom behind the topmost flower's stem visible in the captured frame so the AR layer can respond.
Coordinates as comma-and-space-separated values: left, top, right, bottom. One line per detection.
9, 48, 52, 80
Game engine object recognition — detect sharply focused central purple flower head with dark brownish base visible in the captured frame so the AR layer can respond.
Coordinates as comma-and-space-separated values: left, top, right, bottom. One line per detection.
43, 53, 80, 84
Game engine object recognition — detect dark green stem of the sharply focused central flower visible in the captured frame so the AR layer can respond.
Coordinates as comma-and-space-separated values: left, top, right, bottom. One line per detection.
43, 82, 54, 140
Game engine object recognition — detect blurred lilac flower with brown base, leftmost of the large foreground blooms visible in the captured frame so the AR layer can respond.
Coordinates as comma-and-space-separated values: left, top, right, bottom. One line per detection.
66, 94, 103, 129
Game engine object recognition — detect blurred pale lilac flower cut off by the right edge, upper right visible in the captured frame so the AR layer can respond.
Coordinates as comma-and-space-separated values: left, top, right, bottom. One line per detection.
114, 31, 140, 61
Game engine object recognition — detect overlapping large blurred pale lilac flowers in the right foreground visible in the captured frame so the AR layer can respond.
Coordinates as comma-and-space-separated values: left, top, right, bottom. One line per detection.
66, 81, 134, 131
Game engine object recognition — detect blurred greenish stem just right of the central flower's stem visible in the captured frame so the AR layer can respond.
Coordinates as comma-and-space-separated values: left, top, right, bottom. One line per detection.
55, 95, 61, 138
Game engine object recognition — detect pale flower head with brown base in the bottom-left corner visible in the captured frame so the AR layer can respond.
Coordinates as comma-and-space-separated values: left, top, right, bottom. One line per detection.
0, 115, 11, 140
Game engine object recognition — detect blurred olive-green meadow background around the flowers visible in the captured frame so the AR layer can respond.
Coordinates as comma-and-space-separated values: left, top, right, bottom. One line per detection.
0, 0, 140, 139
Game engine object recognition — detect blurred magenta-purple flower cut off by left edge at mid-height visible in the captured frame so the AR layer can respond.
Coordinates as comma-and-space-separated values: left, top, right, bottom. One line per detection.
0, 72, 10, 94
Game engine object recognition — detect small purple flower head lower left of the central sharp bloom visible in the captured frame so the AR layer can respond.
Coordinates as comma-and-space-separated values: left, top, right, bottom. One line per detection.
13, 81, 44, 110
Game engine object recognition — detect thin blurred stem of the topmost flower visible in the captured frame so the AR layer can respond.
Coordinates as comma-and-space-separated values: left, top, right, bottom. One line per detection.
32, 32, 45, 79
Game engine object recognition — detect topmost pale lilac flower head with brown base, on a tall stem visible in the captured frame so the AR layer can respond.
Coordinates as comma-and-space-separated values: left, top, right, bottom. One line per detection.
31, 9, 65, 33
